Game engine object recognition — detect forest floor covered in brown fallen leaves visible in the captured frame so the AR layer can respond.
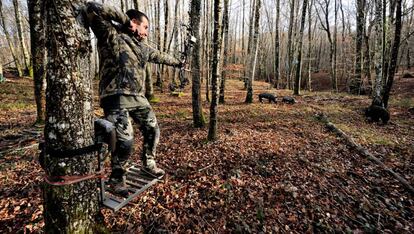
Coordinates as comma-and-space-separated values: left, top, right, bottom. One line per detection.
0, 72, 414, 233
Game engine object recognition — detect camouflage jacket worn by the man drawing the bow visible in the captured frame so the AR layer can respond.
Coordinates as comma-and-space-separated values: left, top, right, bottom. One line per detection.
86, 2, 180, 99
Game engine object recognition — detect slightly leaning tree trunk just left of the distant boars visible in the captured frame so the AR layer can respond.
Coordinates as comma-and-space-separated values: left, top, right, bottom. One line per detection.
245, 0, 261, 103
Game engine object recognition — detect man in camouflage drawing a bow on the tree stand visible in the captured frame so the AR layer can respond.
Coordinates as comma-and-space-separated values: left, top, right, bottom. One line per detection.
86, 2, 183, 194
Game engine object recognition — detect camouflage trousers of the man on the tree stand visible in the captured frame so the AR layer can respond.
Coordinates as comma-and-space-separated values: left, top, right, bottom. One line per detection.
105, 106, 160, 178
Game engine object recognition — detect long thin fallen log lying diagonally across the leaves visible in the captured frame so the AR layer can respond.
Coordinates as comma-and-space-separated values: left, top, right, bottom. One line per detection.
316, 113, 414, 194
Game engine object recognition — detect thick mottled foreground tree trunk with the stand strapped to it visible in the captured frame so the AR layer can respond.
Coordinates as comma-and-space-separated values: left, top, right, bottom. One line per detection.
43, 0, 100, 233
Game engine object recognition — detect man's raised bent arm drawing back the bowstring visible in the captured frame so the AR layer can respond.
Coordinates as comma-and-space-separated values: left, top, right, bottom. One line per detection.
86, 2, 131, 38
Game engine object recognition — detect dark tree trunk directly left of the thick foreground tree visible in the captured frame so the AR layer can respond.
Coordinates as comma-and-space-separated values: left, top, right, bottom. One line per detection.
28, 0, 46, 123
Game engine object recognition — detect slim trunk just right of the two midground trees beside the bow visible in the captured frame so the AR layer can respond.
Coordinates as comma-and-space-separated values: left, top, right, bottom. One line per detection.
219, 0, 229, 103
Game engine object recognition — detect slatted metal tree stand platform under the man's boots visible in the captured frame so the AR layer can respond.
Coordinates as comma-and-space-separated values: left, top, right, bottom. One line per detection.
100, 166, 159, 212
